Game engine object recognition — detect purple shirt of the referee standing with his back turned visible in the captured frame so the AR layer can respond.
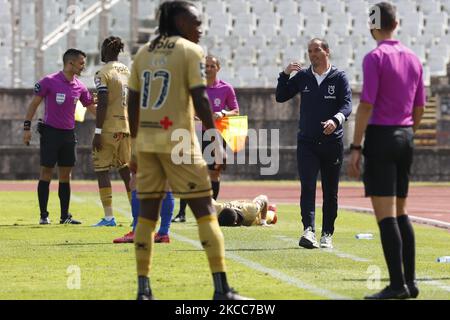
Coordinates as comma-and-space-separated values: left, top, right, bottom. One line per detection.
360, 39, 426, 126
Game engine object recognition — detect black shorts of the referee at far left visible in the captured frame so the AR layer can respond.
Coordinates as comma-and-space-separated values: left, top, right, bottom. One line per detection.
40, 125, 77, 168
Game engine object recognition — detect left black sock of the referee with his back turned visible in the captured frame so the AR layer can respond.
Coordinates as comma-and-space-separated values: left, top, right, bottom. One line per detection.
378, 217, 405, 289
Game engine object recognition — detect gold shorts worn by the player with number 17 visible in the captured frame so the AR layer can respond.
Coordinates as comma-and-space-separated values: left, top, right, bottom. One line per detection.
137, 152, 212, 199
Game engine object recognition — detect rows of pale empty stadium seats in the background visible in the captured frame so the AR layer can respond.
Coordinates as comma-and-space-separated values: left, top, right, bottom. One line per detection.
0, 0, 450, 87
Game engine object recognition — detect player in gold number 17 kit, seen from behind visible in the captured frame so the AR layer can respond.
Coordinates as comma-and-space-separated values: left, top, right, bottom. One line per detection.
128, 1, 250, 300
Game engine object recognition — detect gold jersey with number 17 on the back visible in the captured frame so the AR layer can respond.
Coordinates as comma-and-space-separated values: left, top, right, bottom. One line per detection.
129, 36, 206, 154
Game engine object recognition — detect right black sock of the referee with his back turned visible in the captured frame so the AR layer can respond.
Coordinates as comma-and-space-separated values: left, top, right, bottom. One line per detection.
397, 215, 416, 282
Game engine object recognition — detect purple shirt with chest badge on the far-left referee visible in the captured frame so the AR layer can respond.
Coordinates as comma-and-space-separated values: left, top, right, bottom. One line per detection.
34, 71, 94, 130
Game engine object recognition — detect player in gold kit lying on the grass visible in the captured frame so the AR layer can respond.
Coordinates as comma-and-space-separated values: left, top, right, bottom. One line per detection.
213, 195, 278, 227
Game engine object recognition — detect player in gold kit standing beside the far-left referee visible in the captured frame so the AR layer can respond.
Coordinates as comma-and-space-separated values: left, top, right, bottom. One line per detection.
92, 36, 131, 227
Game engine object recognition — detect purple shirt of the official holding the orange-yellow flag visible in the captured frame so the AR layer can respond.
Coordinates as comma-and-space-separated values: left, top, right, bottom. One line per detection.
206, 80, 239, 113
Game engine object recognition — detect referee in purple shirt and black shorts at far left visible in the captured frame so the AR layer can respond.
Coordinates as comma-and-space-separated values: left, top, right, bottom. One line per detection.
23, 49, 95, 224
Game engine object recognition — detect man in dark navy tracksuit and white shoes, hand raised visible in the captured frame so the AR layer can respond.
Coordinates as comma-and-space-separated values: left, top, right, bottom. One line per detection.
276, 38, 352, 249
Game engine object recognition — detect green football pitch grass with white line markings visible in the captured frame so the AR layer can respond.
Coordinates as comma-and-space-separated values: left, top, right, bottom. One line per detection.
0, 192, 450, 300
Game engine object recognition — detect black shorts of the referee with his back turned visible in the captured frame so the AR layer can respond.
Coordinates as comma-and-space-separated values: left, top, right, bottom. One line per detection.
363, 125, 414, 198
